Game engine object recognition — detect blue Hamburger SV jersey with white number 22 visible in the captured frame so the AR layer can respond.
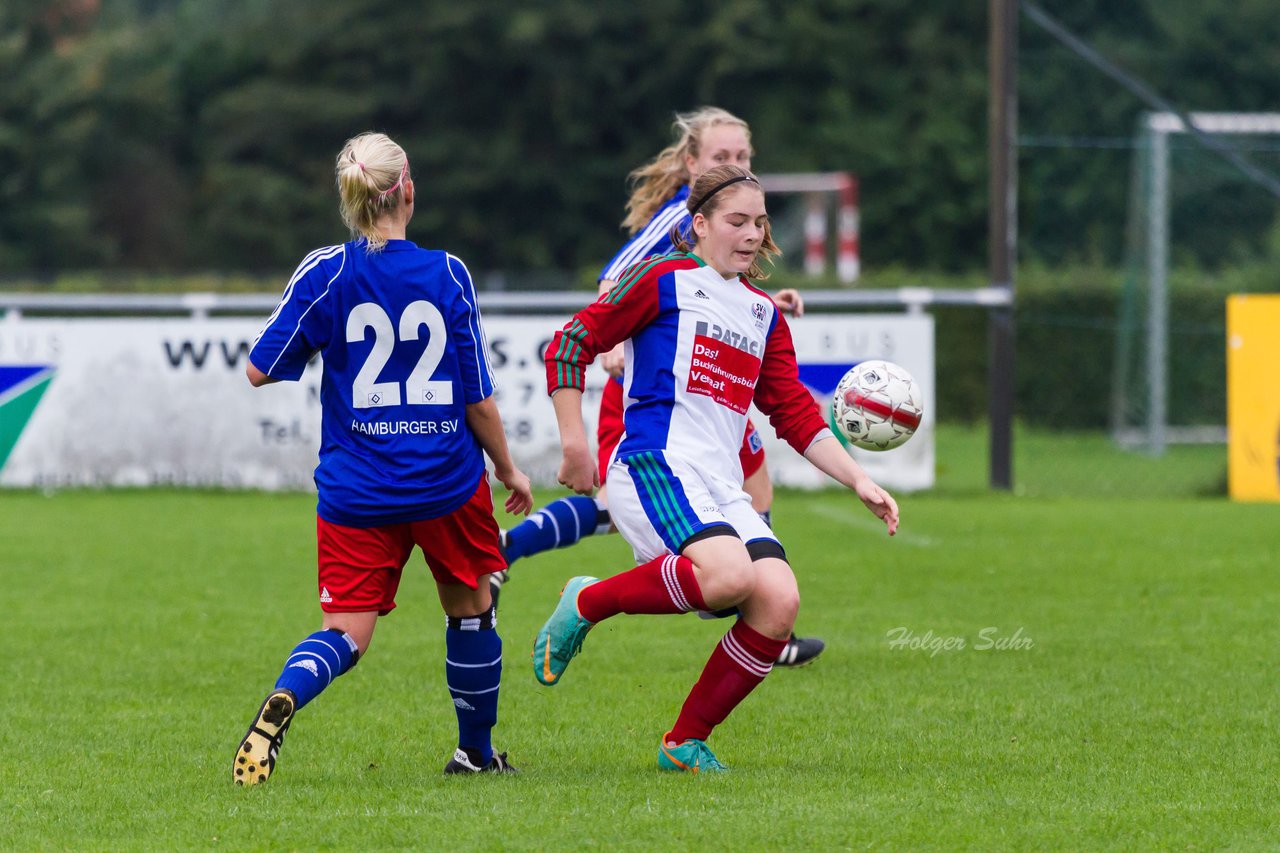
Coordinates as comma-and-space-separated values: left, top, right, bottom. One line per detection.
250, 240, 493, 528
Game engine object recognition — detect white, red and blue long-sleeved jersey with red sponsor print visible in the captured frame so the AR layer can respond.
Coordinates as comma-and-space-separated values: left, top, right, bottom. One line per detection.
545, 254, 829, 491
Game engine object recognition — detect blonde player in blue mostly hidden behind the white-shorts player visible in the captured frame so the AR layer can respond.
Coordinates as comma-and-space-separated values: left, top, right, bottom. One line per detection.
490, 106, 826, 666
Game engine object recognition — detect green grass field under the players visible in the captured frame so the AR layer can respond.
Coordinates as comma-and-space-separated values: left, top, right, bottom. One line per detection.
0, 430, 1280, 850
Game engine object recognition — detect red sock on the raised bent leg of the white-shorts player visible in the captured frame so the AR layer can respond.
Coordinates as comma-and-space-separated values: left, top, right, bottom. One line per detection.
577, 555, 711, 617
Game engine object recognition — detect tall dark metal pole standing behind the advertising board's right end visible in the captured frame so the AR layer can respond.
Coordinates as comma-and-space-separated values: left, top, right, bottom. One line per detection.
987, 0, 1018, 491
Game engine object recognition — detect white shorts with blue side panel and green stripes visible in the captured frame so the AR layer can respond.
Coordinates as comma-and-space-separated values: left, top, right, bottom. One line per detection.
608, 451, 778, 564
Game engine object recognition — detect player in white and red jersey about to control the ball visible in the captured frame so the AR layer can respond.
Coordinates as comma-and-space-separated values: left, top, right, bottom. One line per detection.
532, 165, 899, 772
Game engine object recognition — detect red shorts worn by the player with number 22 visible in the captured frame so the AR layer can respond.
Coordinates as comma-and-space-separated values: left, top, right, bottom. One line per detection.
316, 471, 507, 616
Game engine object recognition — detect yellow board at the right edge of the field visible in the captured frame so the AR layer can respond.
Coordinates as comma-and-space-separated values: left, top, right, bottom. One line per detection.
1226, 293, 1280, 501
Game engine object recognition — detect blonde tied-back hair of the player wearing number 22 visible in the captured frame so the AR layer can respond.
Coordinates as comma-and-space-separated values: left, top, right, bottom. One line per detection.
334, 133, 410, 252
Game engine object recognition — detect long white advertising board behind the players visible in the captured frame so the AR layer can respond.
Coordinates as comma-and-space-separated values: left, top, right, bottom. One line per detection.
0, 314, 933, 489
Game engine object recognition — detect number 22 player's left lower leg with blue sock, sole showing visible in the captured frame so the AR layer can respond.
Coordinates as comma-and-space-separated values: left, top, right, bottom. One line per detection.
232, 628, 360, 785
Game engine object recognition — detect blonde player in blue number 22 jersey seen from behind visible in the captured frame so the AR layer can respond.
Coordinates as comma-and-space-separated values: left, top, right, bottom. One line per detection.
232, 133, 532, 785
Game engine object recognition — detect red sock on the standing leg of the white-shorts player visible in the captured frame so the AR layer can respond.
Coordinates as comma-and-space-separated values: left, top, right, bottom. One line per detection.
665, 617, 787, 744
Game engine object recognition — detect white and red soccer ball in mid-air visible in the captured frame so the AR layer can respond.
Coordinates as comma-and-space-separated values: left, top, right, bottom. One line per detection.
831, 361, 924, 451
